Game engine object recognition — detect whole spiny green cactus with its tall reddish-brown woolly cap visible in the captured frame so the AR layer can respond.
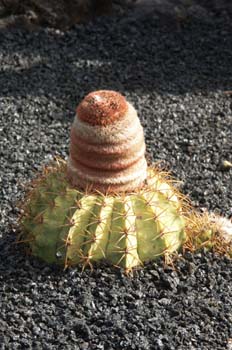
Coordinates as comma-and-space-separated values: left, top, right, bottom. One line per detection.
20, 90, 232, 272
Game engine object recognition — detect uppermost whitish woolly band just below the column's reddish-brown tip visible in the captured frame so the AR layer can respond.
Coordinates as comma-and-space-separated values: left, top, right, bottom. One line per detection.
73, 102, 143, 144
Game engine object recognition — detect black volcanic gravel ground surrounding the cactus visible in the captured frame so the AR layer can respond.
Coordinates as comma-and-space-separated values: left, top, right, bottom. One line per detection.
0, 6, 232, 350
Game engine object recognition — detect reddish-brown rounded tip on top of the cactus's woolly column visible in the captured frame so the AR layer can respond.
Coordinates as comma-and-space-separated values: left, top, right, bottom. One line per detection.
77, 90, 128, 126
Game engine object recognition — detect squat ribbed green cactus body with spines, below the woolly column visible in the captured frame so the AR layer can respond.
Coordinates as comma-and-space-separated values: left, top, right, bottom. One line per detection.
21, 166, 185, 271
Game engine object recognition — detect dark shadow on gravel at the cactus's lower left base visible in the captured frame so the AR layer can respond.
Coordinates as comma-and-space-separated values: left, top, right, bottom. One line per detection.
0, 232, 125, 289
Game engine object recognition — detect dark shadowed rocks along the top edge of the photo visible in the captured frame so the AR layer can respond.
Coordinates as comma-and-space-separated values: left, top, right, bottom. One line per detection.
0, 0, 232, 30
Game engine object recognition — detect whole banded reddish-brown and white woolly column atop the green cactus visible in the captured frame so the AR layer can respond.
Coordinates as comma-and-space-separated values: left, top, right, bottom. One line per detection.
68, 90, 147, 193
